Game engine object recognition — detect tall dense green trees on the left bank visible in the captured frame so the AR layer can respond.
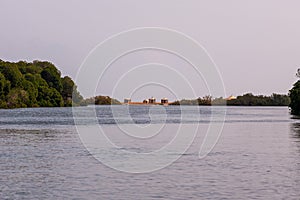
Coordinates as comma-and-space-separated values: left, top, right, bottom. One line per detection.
0, 60, 83, 108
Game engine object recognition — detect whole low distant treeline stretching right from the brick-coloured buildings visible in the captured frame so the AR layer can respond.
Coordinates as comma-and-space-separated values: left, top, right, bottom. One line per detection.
170, 93, 290, 106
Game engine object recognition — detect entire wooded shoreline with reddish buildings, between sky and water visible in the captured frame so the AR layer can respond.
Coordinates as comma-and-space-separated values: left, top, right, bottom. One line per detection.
0, 60, 292, 109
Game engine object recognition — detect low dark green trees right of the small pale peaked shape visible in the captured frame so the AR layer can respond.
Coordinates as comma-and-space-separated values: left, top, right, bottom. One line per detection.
227, 93, 290, 106
